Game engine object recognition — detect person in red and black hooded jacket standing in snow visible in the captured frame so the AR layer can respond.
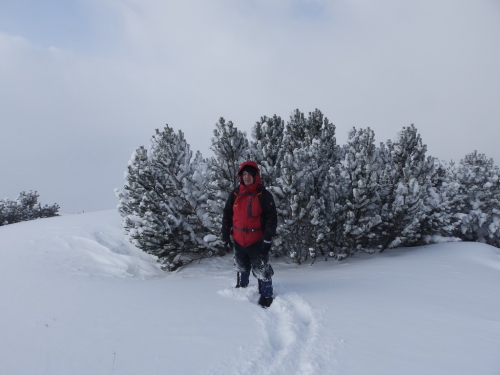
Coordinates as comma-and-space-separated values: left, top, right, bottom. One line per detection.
222, 161, 278, 308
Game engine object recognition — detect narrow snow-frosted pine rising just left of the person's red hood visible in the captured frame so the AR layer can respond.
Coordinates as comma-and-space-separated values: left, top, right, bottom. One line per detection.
204, 117, 250, 235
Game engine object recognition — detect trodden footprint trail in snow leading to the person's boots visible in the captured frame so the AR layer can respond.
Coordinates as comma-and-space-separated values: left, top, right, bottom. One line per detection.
209, 286, 337, 375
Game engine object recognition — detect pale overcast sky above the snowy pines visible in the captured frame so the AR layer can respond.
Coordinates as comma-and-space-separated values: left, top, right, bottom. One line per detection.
0, 0, 500, 213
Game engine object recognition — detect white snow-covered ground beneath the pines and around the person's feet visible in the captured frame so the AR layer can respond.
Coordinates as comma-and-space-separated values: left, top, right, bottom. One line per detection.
0, 210, 500, 375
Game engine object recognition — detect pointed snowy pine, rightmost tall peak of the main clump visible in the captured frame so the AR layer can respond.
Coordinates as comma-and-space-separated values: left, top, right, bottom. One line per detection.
376, 124, 433, 252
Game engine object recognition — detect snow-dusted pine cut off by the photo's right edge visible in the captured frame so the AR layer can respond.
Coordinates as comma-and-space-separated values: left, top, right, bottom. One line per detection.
450, 151, 500, 247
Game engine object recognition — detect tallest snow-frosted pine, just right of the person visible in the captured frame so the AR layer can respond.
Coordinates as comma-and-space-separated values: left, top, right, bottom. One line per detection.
275, 110, 337, 264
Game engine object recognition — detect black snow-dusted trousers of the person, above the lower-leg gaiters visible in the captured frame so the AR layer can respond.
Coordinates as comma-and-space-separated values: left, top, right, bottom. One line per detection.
234, 240, 274, 281
